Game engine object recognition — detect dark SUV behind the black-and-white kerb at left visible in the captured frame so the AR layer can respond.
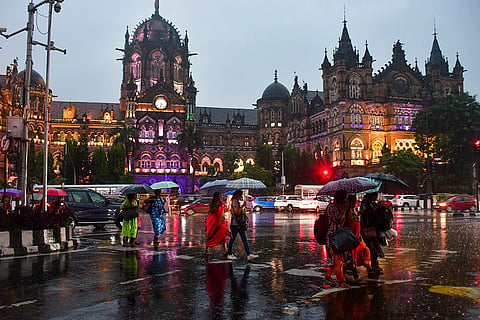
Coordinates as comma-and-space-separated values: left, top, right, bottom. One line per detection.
63, 188, 123, 228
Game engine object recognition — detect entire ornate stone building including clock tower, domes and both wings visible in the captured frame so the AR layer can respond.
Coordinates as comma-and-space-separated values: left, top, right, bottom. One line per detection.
0, 2, 464, 192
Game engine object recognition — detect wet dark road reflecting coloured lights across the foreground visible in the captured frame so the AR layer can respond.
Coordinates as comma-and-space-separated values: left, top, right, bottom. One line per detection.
0, 211, 480, 320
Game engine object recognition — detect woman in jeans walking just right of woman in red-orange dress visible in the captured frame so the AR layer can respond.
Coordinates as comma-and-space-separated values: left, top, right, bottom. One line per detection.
227, 190, 258, 260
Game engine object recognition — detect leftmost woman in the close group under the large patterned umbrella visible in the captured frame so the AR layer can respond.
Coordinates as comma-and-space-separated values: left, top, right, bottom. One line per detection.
325, 190, 350, 288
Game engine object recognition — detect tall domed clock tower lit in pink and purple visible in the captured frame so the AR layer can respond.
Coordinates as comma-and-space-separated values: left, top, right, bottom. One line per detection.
119, 1, 197, 189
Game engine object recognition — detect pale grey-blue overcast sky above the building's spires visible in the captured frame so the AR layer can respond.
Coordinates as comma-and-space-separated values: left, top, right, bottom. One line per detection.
0, 0, 480, 108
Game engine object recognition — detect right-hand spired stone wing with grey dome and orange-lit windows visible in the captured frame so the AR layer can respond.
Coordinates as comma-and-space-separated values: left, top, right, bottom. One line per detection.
257, 21, 464, 178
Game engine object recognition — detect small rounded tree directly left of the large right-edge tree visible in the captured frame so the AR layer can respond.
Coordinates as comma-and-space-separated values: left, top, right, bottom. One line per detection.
381, 150, 423, 192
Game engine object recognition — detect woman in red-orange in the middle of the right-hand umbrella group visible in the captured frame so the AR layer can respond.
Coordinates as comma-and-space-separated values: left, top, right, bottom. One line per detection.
343, 194, 362, 282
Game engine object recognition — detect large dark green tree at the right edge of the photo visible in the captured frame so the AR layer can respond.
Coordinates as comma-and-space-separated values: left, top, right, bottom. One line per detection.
413, 93, 480, 192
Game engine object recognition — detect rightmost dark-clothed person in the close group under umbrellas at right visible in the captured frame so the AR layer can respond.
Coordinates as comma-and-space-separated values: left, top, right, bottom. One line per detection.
359, 192, 384, 274
